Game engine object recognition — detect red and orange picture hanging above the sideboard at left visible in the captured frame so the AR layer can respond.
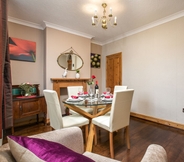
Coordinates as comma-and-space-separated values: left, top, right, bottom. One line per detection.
9, 37, 36, 62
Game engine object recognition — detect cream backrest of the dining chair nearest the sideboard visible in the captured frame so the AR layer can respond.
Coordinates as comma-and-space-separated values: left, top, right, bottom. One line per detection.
43, 89, 63, 129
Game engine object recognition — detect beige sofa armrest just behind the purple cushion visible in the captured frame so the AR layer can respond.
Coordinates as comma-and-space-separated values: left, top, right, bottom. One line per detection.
30, 127, 84, 154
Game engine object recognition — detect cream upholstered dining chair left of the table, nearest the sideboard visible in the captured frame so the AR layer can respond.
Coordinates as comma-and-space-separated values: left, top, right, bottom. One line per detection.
43, 89, 89, 140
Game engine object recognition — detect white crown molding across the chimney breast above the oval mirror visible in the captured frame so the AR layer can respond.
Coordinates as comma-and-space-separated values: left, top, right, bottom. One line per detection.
43, 21, 94, 39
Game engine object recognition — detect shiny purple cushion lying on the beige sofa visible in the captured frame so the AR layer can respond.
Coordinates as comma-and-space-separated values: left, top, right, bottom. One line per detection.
8, 136, 94, 162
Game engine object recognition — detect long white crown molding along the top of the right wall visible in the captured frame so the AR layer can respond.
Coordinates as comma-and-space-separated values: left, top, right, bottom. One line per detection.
102, 10, 184, 45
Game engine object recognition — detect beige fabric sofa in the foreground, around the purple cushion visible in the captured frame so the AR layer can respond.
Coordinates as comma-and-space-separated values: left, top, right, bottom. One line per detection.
0, 127, 167, 162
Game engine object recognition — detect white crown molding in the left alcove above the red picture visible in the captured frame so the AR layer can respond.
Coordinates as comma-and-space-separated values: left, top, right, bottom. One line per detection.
8, 16, 44, 30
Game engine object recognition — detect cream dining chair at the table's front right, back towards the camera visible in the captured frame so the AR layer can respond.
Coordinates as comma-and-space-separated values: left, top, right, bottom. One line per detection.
92, 89, 134, 158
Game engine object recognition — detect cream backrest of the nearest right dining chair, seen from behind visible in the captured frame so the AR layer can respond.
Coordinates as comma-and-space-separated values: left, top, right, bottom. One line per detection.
109, 89, 134, 131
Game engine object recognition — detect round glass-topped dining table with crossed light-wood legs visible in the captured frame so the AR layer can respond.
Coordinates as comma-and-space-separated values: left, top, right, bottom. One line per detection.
63, 98, 112, 152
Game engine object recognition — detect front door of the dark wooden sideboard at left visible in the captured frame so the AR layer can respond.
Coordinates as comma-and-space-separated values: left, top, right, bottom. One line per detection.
19, 99, 40, 118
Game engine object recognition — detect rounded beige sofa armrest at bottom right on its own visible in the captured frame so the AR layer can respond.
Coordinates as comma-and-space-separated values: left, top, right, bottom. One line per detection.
141, 144, 167, 162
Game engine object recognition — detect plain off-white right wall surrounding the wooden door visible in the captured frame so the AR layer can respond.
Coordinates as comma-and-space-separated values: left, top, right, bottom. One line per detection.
102, 17, 184, 124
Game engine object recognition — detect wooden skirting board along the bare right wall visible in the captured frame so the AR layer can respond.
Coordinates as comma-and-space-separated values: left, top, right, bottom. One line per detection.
130, 112, 184, 130
